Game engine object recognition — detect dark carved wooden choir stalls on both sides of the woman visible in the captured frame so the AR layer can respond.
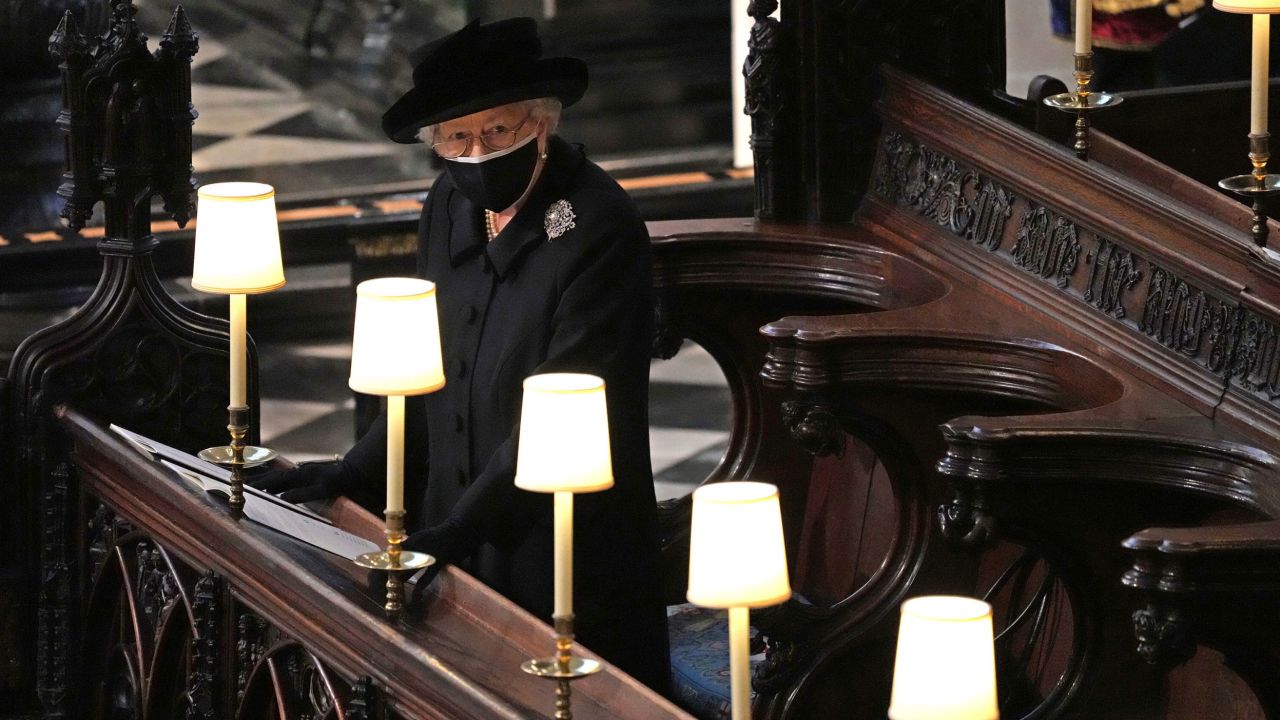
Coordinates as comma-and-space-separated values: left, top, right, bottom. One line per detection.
0, 0, 1280, 720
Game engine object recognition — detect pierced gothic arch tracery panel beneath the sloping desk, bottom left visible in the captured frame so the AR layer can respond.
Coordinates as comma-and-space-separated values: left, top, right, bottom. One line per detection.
76, 486, 378, 720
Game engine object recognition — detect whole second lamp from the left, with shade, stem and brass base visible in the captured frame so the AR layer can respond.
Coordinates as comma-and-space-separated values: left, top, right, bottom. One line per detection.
348, 278, 444, 618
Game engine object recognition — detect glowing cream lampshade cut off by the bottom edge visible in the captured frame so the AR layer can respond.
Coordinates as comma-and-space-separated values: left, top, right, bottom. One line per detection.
888, 596, 1000, 720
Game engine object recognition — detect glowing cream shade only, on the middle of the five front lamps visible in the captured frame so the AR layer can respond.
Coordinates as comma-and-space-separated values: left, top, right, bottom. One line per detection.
516, 373, 613, 492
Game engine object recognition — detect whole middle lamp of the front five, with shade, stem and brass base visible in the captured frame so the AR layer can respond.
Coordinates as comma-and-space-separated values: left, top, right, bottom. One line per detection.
516, 373, 613, 720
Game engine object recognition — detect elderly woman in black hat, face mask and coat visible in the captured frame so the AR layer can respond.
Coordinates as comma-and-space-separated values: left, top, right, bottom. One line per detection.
262, 18, 668, 689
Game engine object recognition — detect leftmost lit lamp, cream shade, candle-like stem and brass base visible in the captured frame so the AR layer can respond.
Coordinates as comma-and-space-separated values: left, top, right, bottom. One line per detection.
191, 182, 284, 511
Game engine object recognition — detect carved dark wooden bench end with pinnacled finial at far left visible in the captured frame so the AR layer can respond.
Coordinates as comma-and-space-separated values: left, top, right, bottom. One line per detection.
4, 0, 267, 716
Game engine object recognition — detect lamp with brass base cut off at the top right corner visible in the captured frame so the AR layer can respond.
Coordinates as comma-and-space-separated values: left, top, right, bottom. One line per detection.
1213, 0, 1280, 249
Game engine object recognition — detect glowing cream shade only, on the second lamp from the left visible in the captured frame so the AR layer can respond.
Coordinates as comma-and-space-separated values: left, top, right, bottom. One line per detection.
347, 278, 444, 395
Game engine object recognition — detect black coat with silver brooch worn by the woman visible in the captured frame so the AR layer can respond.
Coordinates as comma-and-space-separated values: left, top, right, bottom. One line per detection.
344, 137, 668, 688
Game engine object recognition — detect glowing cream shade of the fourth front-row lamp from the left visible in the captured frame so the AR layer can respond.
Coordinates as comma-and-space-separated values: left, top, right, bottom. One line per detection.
687, 482, 791, 607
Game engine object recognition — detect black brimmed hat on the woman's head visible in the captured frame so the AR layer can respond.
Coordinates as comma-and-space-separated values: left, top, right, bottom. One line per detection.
373, 18, 586, 142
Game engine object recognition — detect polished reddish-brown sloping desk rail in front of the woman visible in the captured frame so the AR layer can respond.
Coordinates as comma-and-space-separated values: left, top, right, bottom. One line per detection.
59, 409, 689, 719
